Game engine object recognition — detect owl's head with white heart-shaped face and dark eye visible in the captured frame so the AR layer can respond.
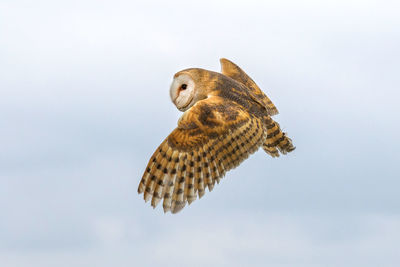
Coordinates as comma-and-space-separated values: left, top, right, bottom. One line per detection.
169, 69, 215, 111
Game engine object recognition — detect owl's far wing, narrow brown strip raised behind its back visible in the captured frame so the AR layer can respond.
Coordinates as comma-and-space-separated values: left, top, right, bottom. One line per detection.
220, 58, 278, 116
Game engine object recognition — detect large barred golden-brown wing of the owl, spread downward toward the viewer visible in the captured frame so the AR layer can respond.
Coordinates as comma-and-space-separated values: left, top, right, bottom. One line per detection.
138, 96, 266, 213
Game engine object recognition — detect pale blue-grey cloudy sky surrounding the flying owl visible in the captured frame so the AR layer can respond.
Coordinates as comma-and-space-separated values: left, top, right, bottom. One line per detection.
0, 0, 400, 267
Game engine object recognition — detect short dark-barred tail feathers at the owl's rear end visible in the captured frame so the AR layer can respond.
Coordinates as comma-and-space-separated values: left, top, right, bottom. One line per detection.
263, 116, 296, 158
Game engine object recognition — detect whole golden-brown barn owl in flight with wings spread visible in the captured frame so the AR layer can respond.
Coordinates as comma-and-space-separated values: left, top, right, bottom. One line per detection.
138, 58, 295, 213
